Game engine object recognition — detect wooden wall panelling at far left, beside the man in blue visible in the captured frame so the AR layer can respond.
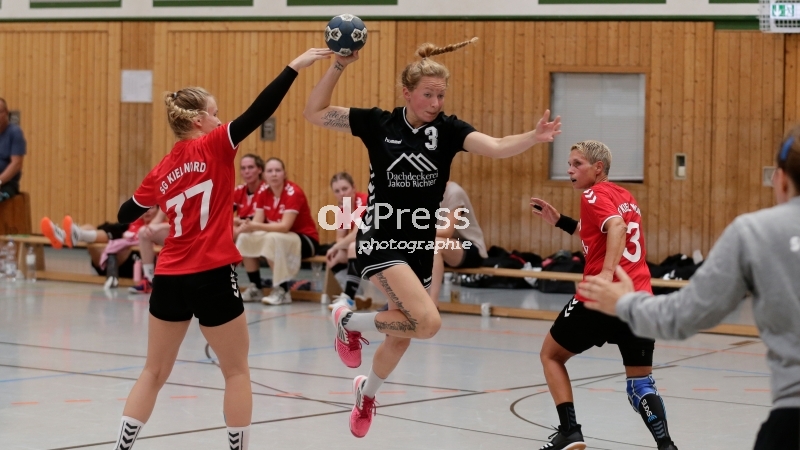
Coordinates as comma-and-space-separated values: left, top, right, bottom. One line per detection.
0, 22, 120, 232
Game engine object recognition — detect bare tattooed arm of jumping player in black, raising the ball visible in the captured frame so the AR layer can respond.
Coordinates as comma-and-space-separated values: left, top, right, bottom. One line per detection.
303, 52, 358, 133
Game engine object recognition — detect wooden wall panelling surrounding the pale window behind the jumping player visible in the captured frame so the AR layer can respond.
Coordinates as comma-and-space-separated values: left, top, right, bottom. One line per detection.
390, 22, 713, 260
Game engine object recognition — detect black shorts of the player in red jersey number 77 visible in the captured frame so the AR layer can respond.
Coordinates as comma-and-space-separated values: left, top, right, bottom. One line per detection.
150, 264, 244, 327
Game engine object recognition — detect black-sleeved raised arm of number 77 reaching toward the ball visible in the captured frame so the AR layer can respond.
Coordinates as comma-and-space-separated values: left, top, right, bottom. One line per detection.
230, 48, 333, 146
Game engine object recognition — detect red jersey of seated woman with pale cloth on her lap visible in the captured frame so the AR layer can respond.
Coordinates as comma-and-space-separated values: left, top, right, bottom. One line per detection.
253, 180, 319, 242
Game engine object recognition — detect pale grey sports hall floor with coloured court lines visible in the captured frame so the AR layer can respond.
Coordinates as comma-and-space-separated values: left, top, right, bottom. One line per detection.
0, 248, 770, 450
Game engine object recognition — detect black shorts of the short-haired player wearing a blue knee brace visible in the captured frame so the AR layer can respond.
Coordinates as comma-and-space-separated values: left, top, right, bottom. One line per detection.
550, 297, 656, 366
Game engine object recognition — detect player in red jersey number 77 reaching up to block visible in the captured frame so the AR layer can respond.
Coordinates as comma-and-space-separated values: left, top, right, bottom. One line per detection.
114, 49, 331, 450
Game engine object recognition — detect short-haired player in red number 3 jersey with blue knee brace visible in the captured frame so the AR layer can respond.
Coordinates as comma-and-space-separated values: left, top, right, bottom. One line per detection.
531, 141, 677, 450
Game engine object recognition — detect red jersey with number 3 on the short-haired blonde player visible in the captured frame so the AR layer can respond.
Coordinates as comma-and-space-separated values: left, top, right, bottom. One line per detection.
575, 182, 653, 301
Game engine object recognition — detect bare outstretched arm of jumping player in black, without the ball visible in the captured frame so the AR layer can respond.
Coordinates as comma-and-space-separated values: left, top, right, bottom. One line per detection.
464, 109, 561, 158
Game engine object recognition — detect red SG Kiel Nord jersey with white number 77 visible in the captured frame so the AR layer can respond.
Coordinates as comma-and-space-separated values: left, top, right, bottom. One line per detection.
133, 123, 242, 275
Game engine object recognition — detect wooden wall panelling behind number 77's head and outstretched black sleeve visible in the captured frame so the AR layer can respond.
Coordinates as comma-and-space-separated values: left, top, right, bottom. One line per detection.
152, 22, 394, 246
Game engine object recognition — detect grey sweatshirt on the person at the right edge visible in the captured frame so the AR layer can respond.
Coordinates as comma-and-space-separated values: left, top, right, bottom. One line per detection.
616, 197, 800, 408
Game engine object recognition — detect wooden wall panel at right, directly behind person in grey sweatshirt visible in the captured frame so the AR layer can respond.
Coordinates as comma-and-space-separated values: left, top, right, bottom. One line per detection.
709, 31, 793, 243
